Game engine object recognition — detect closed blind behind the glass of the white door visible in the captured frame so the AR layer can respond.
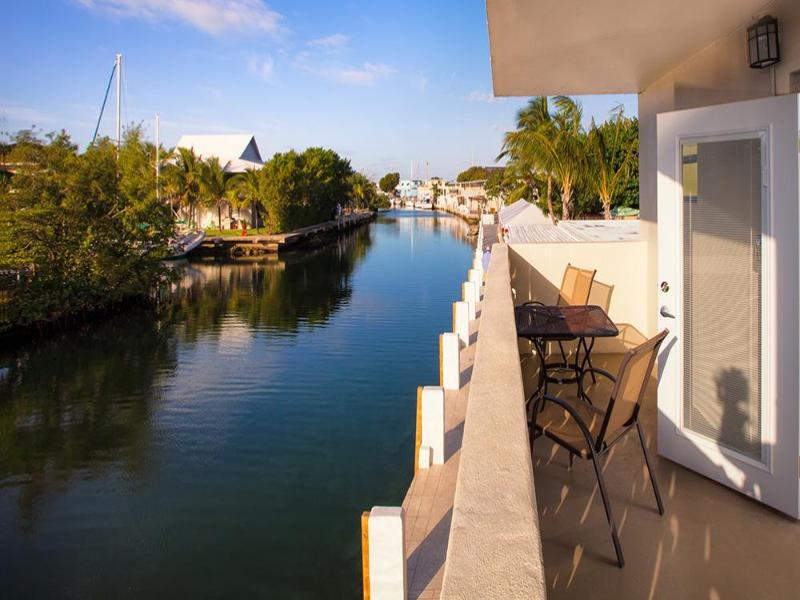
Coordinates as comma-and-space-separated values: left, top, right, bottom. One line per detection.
681, 138, 762, 460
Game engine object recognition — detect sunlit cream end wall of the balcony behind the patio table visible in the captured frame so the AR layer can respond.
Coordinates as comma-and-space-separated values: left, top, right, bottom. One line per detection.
509, 241, 657, 353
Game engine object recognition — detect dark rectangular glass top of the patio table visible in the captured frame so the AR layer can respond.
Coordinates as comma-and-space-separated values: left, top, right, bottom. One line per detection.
514, 304, 619, 341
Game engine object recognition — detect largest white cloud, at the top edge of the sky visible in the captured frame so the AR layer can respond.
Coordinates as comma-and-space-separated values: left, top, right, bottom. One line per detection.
76, 0, 282, 35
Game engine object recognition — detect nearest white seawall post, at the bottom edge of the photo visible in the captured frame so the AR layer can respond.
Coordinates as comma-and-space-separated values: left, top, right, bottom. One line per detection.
369, 506, 408, 600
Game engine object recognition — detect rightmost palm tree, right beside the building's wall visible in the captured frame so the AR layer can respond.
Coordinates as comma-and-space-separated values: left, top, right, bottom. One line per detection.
587, 105, 638, 219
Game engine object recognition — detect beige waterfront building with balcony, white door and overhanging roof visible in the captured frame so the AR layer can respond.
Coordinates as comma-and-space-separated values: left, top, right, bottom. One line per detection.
360, 0, 800, 600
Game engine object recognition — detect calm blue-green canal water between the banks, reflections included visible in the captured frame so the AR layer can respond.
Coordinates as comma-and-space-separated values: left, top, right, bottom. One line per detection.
0, 212, 470, 598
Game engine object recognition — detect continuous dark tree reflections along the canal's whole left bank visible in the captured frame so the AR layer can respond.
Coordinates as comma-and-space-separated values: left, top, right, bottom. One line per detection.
0, 228, 371, 528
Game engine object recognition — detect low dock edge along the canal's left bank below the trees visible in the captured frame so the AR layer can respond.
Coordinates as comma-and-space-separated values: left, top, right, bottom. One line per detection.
195, 211, 375, 256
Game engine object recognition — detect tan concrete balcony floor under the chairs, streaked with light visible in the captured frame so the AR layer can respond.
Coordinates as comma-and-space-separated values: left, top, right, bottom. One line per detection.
524, 355, 800, 600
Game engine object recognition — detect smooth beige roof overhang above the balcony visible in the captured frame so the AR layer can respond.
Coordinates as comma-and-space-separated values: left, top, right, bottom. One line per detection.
486, 0, 776, 96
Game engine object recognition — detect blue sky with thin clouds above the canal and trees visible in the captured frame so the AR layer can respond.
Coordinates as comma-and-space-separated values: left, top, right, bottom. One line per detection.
0, 0, 636, 178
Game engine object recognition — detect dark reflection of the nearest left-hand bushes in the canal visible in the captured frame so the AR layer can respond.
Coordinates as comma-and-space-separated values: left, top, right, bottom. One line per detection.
0, 311, 176, 527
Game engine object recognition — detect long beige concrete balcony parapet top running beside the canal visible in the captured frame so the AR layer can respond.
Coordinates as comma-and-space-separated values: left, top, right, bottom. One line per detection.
441, 244, 545, 600
